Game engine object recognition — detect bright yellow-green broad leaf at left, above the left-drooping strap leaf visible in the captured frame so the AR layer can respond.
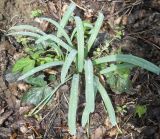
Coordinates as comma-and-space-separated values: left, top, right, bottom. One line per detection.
12, 57, 35, 73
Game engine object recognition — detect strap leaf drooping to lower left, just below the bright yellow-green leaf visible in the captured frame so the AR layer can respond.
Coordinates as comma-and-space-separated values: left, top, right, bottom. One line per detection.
18, 61, 63, 81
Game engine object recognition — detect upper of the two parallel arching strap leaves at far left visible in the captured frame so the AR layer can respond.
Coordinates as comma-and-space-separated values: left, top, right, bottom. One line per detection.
9, 25, 46, 35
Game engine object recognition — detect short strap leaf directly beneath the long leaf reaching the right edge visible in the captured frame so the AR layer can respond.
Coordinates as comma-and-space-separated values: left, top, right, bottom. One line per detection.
100, 63, 135, 74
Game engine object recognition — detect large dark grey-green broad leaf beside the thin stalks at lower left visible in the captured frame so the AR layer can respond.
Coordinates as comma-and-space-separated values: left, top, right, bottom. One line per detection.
21, 87, 52, 105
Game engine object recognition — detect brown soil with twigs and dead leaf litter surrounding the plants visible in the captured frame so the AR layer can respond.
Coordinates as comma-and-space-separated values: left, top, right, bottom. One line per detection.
0, 0, 160, 139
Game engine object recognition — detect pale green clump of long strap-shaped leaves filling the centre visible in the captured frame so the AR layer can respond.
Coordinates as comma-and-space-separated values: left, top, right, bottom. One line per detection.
8, 3, 160, 135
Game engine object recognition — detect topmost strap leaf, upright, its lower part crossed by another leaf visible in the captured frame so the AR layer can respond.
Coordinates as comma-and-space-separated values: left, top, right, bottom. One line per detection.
57, 3, 76, 37
